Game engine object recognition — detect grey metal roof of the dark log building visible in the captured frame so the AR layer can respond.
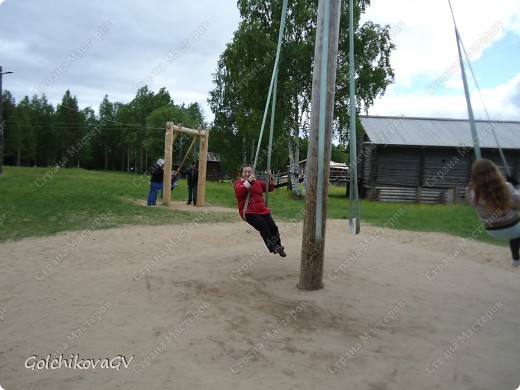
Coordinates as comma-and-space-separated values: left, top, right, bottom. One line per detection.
359, 116, 520, 149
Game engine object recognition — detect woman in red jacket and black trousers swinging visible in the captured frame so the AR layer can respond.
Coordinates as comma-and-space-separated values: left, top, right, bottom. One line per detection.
234, 164, 287, 257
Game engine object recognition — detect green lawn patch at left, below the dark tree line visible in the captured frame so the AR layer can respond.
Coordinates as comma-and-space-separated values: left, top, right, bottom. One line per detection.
0, 167, 236, 242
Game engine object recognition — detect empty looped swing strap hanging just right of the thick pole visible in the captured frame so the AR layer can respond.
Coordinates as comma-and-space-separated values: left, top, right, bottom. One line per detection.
348, 0, 361, 235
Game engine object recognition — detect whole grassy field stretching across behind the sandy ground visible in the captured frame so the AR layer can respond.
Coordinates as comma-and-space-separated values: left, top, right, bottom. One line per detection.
0, 167, 507, 245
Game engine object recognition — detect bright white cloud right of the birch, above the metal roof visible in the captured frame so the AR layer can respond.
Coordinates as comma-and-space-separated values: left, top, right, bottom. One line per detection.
363, 0, 520, 120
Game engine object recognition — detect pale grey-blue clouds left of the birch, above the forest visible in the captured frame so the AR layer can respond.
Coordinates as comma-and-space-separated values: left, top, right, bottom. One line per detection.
0, 0, 239, 118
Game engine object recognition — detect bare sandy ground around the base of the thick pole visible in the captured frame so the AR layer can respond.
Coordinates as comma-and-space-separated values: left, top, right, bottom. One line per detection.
0, 204, 520, 390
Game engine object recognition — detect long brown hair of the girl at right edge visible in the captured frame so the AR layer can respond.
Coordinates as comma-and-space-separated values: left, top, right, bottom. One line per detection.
470, 158, 512, 210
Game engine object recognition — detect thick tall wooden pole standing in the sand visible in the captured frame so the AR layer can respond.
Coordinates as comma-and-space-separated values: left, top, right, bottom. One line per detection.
298, 0, 341, 290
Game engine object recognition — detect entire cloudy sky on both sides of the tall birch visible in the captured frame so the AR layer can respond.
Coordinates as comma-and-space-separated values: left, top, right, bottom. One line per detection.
0, 0, 520, 120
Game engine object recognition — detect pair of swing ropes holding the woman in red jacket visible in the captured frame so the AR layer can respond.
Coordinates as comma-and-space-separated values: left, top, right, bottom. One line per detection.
242, 0, 288, 219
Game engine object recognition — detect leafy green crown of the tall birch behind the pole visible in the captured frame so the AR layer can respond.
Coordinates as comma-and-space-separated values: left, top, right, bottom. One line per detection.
209, 0, 394, 174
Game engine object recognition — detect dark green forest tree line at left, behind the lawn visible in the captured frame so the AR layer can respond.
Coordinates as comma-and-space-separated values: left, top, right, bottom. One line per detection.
3, 86, 204, 172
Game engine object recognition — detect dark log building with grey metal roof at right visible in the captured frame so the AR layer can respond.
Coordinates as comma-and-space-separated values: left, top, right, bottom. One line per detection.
357, 116, 520, 203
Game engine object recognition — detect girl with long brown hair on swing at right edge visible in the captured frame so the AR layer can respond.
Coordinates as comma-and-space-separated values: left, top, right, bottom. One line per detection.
467, 159, 520, 266
